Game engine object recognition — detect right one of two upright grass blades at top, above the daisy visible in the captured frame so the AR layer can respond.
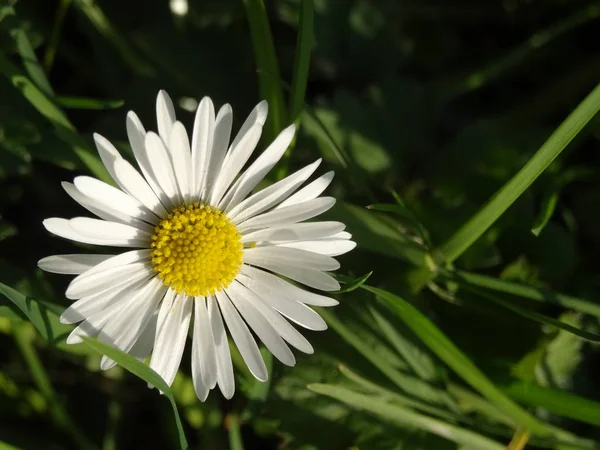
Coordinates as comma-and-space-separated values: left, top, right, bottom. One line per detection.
290, 0, 314, 121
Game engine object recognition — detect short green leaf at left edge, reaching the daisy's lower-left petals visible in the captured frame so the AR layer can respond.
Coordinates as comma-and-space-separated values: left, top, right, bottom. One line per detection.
0, 283, 72, 344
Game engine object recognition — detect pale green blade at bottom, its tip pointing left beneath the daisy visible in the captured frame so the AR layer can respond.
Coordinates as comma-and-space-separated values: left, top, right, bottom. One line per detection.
308, 384, 505, 450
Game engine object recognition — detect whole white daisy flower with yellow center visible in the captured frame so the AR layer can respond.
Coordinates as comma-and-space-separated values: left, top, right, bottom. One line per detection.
38, 91, 356, 401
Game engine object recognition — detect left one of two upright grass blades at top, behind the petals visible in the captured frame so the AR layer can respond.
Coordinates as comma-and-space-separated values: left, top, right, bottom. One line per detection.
243, 0, 286, 142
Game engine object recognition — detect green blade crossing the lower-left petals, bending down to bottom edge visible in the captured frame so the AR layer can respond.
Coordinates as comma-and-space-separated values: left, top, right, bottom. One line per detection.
83, 337, 188, 449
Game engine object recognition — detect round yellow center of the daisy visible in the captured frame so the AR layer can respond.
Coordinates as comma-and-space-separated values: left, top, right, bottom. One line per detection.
151, 202, 243, 296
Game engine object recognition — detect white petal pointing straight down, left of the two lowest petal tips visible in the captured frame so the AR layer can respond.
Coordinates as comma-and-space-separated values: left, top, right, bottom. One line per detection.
192, 297, 218, 392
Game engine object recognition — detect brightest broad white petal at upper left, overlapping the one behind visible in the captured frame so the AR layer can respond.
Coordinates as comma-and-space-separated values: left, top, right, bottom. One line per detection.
73, 176, 158, 224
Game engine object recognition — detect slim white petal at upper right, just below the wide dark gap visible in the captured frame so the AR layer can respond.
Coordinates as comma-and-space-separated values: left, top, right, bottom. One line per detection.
229, 159, 321, 224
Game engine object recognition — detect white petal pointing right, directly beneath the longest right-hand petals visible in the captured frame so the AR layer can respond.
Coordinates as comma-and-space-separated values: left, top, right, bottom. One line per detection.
244, 246, 340, 270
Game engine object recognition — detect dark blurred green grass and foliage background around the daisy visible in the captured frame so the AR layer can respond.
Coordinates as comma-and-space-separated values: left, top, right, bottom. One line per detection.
0, 0, 600, 450
